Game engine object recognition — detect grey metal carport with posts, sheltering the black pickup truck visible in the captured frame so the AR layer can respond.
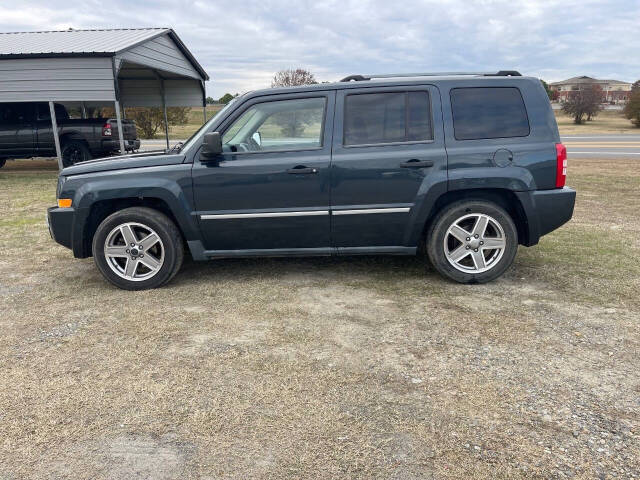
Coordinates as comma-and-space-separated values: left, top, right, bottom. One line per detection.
0, 28, 209, 168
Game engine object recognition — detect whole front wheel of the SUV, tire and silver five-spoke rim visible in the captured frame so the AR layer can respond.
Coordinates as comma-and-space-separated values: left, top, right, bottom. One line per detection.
92, 207, 184, 290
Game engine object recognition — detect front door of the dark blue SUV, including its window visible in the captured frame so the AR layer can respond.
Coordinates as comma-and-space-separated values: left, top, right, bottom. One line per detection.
193, 91, 335, 256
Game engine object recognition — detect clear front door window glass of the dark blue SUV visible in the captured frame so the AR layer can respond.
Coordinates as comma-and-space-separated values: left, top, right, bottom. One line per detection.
222, 97, 326, 153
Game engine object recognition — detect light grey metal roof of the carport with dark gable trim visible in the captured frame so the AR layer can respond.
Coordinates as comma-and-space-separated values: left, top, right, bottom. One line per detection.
0, 28, 209, 80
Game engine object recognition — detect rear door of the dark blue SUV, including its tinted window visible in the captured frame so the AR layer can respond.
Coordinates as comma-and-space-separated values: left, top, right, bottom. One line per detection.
331, 85, 447, 254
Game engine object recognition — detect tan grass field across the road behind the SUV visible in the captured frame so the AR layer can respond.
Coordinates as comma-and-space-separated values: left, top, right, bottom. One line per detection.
157, 106, 640, 140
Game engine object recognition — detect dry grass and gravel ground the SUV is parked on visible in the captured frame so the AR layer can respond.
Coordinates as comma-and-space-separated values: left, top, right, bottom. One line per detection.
0, 160, 640, 480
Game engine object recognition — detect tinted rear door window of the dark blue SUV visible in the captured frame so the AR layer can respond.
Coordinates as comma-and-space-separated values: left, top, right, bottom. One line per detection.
344, 91, 433, 145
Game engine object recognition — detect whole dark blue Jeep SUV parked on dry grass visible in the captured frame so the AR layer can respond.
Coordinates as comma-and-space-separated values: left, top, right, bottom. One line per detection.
48, 71, 575, 290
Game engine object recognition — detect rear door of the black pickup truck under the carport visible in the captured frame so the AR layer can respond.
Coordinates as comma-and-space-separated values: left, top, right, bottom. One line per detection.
0, 103, 34, 156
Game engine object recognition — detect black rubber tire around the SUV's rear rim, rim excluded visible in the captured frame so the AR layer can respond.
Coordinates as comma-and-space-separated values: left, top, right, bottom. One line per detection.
427, 200, 518, 283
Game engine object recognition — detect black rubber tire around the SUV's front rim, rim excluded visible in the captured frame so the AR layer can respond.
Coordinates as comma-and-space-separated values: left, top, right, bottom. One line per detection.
92, 208, 182, 290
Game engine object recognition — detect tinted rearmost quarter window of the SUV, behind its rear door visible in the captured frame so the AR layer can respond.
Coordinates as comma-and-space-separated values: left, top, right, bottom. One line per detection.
451, 87, 529, 140
